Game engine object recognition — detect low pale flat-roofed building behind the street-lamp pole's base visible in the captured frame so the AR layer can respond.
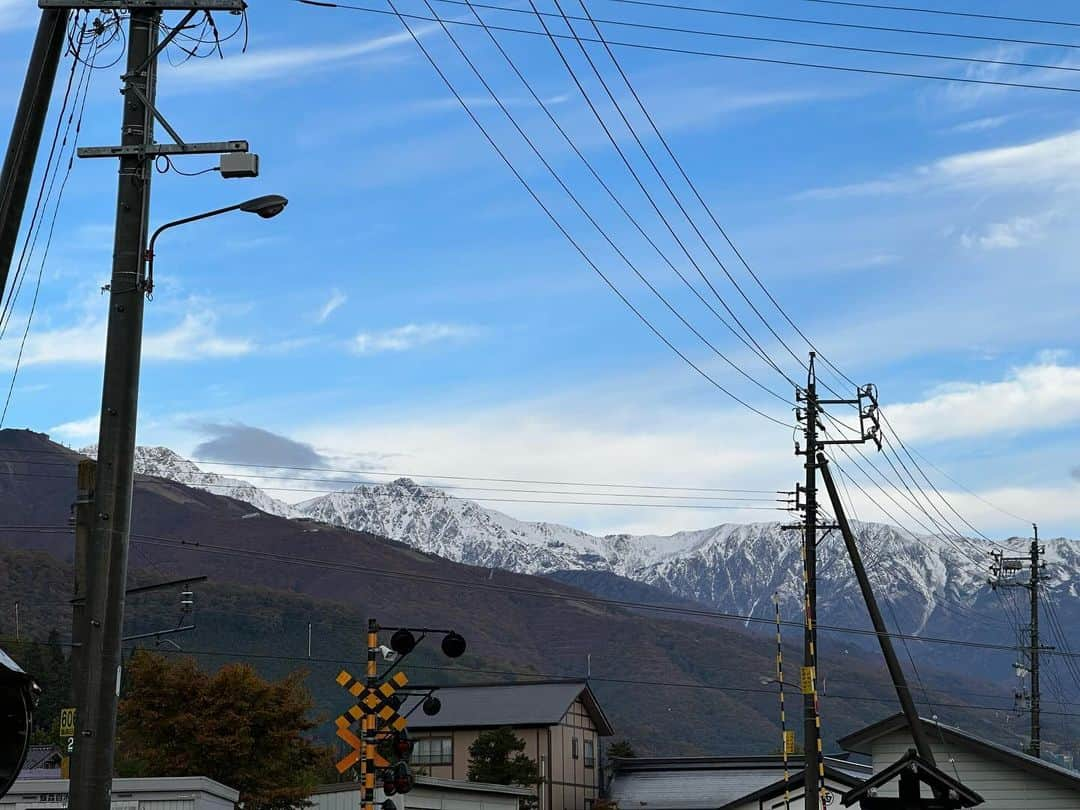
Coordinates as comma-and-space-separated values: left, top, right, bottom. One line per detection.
0, 777, 240, 810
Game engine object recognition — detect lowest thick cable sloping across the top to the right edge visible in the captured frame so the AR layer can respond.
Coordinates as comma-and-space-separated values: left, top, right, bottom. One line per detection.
292, 0, 1080, 93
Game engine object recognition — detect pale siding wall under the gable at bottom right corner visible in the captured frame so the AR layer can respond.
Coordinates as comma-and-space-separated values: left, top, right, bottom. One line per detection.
872, 729, 1080, 810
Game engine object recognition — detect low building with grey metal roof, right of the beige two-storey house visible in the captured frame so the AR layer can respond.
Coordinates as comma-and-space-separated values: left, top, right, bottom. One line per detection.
608, 755, 872, 810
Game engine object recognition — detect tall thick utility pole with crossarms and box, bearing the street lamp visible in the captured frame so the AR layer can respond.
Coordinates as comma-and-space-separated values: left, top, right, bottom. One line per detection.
48, 0, 252, 810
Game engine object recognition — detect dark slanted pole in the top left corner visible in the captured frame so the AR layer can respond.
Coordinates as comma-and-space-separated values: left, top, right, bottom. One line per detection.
0, 9, 70, 295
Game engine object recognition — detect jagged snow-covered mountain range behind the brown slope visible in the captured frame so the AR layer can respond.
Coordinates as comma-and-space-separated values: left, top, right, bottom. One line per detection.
103, 447, 1080, 682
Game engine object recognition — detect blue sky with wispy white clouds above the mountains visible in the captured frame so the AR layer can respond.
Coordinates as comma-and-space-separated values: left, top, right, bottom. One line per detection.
0, 0, 1080, 537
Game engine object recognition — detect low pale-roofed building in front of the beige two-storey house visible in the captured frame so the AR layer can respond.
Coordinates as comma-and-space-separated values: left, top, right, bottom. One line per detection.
309, 775, 536, 810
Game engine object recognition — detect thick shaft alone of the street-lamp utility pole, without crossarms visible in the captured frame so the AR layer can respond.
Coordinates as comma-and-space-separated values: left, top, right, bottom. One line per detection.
69, 8, 161, 810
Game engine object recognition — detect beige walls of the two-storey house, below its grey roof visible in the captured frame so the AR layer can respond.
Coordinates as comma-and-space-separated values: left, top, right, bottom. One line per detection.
410, 700, 600, 810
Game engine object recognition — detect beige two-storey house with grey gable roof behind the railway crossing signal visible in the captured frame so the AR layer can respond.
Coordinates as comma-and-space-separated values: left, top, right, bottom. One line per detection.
401, 680, 613, 810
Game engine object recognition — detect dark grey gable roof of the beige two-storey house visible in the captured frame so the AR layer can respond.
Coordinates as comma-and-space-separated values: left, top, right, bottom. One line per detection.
400, 680, 615, 737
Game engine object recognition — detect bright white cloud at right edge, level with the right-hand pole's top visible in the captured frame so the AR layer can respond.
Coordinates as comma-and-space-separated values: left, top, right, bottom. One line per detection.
888, 362, 1080, 441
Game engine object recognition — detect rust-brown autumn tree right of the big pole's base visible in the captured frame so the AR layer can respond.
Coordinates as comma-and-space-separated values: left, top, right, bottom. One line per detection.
117, 651, 330, 810
